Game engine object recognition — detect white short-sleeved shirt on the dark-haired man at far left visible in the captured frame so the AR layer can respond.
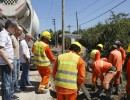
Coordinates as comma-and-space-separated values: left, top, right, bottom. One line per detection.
0, 29, 14, 65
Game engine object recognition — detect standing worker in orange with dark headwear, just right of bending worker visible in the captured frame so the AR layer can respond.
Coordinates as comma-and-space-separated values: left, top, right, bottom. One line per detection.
108, 45, 122, 94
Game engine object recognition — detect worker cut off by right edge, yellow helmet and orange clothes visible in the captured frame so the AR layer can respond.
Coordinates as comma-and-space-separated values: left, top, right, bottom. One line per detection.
126, 45, 130, 100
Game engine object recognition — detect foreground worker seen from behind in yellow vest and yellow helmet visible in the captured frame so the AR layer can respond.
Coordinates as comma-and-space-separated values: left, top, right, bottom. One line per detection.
53, 42, 85, 100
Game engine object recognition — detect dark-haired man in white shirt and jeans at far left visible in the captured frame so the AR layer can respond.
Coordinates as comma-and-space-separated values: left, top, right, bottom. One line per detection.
0, 19, 17, 100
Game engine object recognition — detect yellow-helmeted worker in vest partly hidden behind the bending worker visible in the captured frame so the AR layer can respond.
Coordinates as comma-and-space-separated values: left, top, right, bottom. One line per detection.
90, 44, 107, 87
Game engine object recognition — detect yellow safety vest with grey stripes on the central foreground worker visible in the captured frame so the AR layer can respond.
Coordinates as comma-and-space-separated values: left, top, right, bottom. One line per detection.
55, 52, 79, 89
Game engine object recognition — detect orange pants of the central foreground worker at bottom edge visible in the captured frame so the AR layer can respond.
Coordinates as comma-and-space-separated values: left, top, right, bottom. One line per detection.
57, 92, 77, 100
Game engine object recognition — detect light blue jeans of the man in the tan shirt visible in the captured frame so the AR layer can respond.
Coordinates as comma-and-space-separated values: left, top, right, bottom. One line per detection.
14, 59, 20, 90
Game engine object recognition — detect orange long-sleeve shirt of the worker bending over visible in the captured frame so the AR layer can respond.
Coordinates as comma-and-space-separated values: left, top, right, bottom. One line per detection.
92, 59, 112, 82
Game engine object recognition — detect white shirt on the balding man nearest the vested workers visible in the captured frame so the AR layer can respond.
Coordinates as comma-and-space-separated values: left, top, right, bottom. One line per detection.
20, 40, 30, 63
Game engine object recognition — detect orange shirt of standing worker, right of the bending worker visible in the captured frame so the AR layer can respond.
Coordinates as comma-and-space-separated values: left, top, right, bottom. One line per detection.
108, 49, 122, 71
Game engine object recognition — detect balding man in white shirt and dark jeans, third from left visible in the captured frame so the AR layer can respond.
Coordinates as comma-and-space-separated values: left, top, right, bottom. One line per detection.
20, 34, 32, 91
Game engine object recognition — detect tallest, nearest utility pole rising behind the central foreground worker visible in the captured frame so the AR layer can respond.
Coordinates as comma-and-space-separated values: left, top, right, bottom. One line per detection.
62, 0, 65, 53
